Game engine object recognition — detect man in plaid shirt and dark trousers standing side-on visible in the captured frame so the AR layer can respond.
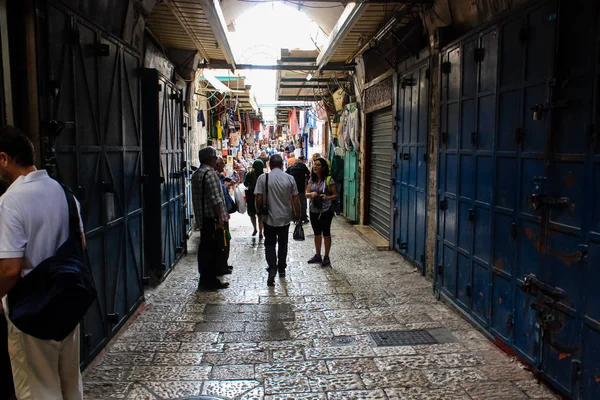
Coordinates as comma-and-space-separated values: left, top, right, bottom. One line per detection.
192, 147, 229, 289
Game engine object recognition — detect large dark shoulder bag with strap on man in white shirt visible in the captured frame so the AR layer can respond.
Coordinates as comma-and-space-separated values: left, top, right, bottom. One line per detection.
8, 186, 96, 341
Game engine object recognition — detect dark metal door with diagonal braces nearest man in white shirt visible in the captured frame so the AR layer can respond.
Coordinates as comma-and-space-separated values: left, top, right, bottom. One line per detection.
36, 3, 144, 365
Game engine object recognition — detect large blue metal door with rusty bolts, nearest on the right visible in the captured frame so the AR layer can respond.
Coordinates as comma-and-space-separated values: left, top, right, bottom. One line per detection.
437, 0, 600, 399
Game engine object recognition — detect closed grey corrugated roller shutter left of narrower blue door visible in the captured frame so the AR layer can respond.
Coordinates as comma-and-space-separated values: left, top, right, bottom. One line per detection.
369, 108, 393, 238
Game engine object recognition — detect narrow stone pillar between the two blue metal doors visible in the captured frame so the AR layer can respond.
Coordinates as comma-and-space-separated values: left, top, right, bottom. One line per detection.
425, 50, 441, 278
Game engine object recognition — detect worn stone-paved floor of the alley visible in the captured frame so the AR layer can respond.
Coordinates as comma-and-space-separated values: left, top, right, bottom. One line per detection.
84, 214, 558, 400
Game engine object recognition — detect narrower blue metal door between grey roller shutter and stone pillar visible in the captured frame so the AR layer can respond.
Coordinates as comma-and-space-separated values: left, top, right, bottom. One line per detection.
392, 63, 429, 271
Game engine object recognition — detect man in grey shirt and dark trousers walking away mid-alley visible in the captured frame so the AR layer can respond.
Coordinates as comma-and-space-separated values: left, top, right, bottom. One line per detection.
254, 154, 300, 286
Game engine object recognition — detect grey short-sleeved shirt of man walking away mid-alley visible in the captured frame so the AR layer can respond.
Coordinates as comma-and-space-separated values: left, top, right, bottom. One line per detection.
254, 168, 298, 226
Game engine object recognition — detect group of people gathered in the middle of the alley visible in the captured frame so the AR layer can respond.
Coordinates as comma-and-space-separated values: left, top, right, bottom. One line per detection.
192, 143, 337, 290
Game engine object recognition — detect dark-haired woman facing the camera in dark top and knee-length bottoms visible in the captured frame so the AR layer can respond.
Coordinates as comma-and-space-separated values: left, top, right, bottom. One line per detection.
306, 157, 337, 267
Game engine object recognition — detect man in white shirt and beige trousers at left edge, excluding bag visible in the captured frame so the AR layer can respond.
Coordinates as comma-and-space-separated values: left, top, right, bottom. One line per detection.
0, 126, 85, 400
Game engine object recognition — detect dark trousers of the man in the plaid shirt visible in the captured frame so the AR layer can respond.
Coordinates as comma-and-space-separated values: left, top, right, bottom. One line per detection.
198, 218, 226, 284
